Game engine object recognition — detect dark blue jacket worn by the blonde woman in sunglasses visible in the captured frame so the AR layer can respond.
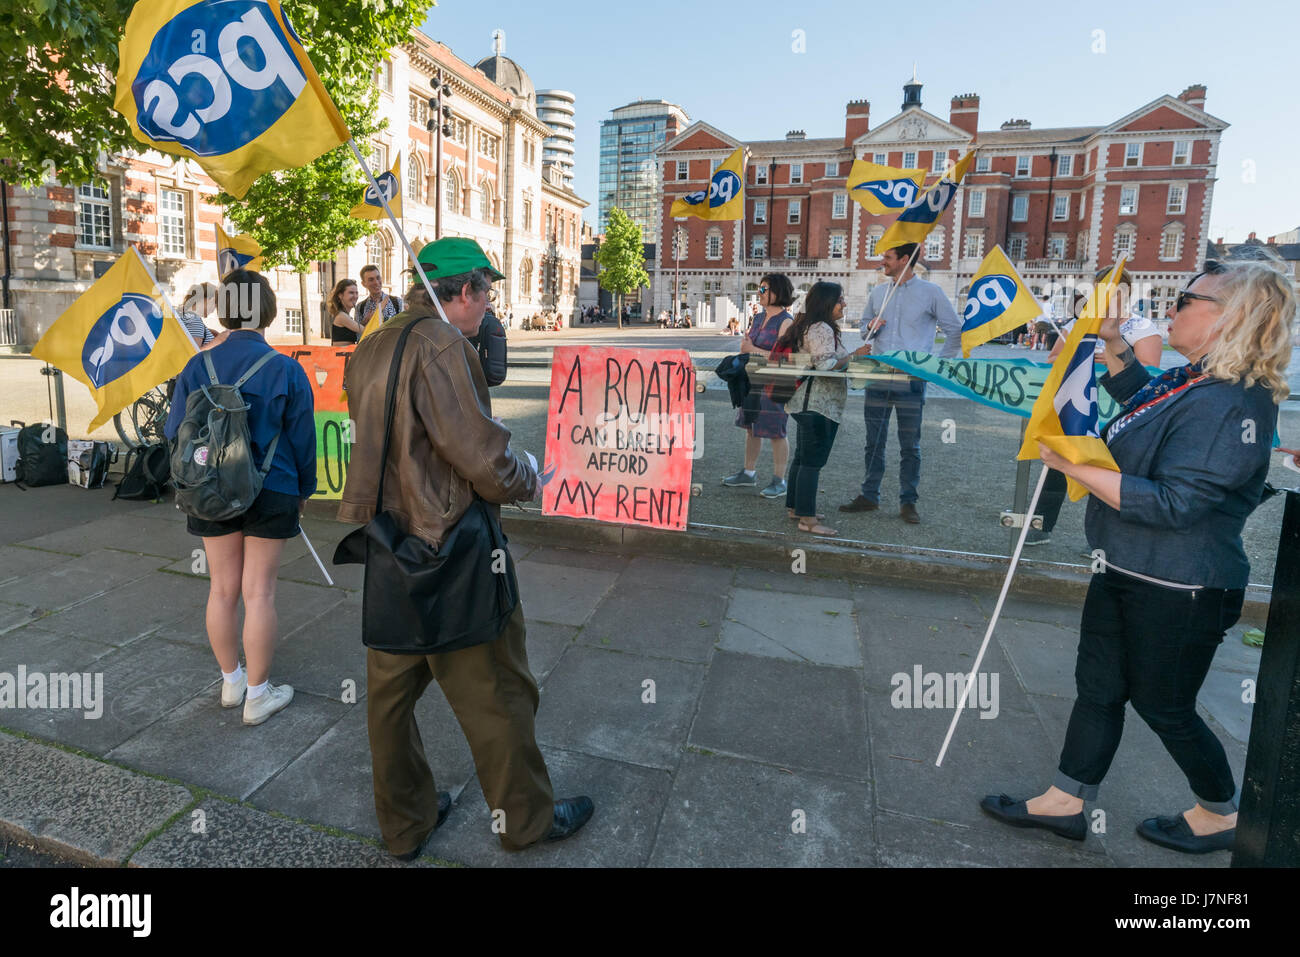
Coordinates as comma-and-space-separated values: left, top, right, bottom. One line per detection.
1084, 363, 1278, 588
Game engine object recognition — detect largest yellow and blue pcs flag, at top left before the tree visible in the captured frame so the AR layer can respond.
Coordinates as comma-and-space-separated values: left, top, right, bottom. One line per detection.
113, 0, 351, 199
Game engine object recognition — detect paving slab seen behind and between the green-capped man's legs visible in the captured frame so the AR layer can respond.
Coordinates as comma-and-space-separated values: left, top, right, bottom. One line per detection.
250, 683, 475, 840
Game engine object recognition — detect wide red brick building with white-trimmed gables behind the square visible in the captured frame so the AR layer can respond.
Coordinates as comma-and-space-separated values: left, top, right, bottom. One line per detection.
654, 82, 1227, 324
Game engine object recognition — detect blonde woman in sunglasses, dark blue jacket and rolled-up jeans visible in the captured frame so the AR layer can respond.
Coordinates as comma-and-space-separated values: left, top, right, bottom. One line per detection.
980, 261, 1296, 854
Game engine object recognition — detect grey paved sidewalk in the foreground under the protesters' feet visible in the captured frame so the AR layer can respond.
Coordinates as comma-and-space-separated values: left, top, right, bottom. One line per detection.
0, 486, 1258, 867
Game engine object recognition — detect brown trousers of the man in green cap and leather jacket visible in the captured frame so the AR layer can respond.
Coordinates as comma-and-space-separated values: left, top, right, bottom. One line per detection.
365, 603, 554, 854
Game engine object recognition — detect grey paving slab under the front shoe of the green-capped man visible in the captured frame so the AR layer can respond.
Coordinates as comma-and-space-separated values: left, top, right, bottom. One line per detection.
426, 748, 672, 867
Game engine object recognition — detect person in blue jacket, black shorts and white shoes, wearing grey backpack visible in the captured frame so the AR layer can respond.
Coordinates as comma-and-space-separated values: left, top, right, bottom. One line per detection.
165, 269, 316, 724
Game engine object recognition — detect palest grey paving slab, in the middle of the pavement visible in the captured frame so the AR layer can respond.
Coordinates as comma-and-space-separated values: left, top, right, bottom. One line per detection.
579, 582, 727, 662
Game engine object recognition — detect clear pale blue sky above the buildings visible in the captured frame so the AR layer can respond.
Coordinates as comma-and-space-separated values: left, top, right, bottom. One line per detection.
425, 0, 1300, 242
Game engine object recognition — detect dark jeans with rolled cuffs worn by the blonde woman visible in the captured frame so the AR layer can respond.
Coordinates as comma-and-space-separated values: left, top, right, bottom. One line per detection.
1056, 571, 1245, 814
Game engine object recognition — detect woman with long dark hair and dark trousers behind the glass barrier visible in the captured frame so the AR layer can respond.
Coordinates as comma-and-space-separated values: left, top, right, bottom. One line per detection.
774, 282, 857, 537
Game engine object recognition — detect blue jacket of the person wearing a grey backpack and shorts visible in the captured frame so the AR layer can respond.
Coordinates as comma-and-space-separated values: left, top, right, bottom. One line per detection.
164, 329, 316, 498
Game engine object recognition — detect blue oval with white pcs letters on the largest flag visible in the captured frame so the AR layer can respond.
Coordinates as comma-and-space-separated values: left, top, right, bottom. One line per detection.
131, 0, 307, 156
